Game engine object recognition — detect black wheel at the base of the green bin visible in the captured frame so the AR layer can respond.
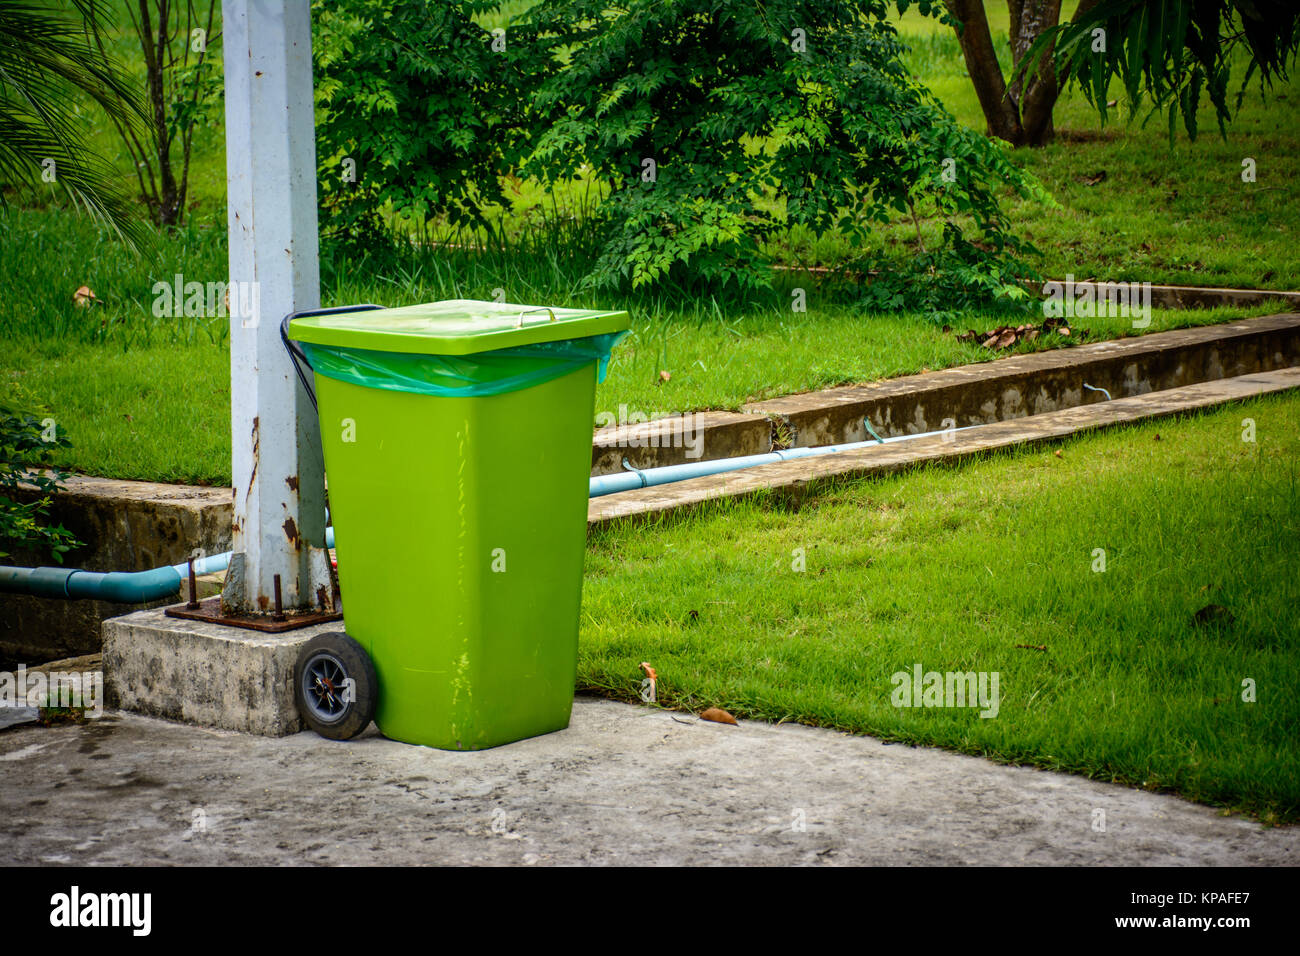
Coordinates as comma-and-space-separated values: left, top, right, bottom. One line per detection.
294, 631, 378, 740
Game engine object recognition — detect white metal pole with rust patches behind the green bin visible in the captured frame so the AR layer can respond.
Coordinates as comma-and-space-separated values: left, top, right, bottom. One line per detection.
222, 0, 329, 613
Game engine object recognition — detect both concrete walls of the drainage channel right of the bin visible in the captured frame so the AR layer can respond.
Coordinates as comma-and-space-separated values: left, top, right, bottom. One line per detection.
588, 313, 1300, 523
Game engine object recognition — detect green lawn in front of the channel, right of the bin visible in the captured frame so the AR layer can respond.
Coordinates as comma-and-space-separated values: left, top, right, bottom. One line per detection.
579, 395, 1300, 822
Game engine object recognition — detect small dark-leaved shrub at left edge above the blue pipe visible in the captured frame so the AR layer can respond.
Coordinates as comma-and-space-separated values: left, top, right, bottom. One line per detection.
0, 406, 79, 563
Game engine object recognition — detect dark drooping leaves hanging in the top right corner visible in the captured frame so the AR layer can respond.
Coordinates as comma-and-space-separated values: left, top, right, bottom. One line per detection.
1021, 0, 1300, 143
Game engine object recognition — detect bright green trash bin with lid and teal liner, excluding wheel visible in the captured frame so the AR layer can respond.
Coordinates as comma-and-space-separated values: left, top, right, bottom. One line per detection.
286, 299, 628, 750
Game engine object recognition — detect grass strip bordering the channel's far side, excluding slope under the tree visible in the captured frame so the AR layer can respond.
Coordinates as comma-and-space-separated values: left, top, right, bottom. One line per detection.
0, 201, 1277, 485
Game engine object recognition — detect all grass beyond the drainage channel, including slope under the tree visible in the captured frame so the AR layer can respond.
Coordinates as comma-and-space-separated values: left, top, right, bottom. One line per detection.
0, 0, 1300, 483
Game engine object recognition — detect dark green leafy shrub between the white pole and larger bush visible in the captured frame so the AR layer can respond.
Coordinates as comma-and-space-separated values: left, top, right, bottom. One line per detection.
312, 0, 545, 239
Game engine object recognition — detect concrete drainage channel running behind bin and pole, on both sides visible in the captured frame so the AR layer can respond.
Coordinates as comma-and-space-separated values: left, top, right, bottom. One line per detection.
0, 313, 1300, 665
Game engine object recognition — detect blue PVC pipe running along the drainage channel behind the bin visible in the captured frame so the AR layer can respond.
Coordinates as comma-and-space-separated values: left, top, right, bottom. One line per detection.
0, 425, 974, 604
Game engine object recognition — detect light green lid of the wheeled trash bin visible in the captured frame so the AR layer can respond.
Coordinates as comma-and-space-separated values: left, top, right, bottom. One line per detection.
289, 299, 629, 355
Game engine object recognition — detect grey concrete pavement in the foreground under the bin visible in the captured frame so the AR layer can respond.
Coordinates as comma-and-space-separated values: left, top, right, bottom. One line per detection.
0, 697, 1300, 866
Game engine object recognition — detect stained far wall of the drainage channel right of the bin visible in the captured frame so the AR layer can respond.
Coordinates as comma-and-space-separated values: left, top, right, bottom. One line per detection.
592, 312, 1300, 475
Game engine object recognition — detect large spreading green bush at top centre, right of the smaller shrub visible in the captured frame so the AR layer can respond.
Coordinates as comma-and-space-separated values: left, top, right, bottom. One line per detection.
524, 0, 1035, 304
